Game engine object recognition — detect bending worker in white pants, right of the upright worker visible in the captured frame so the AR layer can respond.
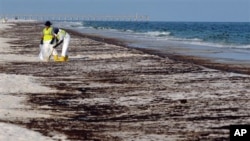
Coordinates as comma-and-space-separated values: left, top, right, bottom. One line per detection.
53, 28, 70, 62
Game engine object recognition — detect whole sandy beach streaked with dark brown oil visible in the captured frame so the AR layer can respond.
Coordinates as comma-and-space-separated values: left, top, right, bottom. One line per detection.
0, 22, 250, 141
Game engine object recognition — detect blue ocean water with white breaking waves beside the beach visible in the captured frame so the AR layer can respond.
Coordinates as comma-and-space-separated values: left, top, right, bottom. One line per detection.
57, 21, 250, 63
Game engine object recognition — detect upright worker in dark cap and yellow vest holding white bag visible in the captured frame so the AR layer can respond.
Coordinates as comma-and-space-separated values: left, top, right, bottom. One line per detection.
39, 21, 58, 61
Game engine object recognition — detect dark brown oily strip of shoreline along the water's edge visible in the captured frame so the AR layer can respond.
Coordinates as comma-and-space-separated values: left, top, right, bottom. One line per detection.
67, 29, 250, 74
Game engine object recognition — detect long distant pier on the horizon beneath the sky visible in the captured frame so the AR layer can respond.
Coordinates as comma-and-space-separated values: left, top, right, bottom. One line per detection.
0, 14, 149, 21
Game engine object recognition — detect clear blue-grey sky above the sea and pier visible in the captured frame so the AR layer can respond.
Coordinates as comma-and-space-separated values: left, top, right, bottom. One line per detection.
0, 0, 250, 22
